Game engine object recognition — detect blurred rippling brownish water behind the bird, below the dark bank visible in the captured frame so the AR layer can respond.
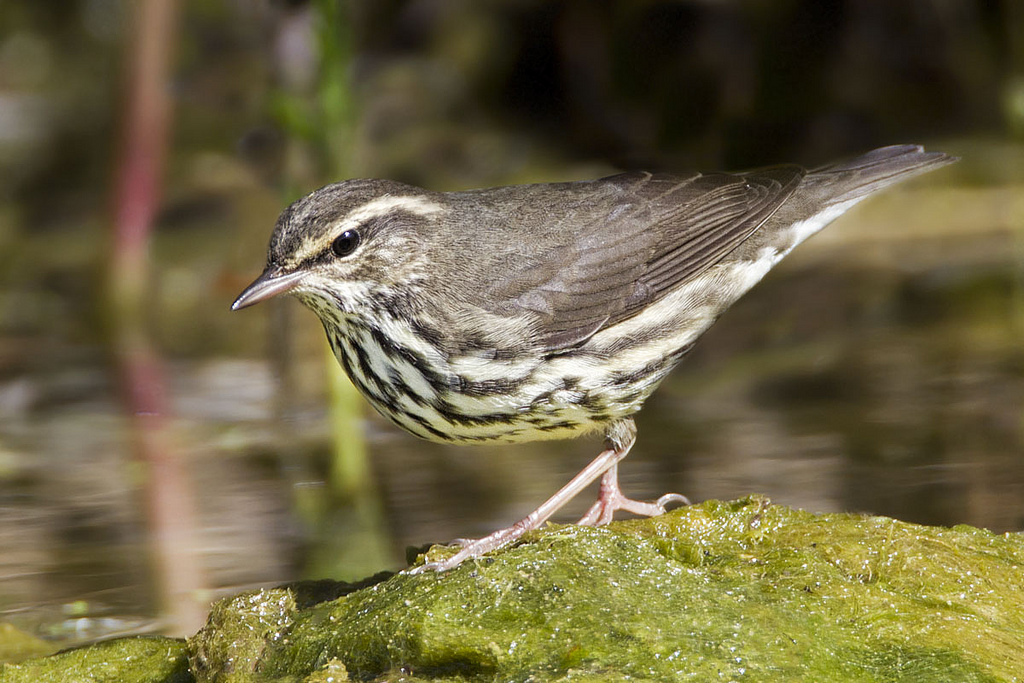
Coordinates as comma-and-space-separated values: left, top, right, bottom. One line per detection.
0, 205, 1024, 639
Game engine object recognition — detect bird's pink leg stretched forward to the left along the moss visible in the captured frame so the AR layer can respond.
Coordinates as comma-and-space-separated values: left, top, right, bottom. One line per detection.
411, 418, 638, 573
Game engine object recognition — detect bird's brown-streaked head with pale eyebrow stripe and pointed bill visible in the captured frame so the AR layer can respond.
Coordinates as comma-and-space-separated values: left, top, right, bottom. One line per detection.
231, 180, 444, 317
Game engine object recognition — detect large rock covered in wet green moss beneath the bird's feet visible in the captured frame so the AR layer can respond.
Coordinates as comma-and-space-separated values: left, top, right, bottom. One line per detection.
0, 498, 1024, 683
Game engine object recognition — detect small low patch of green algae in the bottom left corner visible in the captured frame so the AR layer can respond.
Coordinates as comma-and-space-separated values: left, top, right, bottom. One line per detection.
0, 636, 195, 683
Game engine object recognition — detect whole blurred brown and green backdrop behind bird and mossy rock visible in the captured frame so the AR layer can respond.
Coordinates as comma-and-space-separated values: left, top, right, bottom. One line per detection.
0, 0, 1024, 654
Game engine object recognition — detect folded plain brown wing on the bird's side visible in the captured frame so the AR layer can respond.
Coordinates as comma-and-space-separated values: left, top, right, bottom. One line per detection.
502, 166, 805, 350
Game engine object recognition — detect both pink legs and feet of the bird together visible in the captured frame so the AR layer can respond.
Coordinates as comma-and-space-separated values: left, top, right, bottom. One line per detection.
411, 418, 689, 573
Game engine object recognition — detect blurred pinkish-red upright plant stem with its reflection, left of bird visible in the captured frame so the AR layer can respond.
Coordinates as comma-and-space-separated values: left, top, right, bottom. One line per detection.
110, 0, 206, 634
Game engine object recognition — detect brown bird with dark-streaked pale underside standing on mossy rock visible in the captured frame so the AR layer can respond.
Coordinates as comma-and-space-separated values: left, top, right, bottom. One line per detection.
231, 144, 956, 571
